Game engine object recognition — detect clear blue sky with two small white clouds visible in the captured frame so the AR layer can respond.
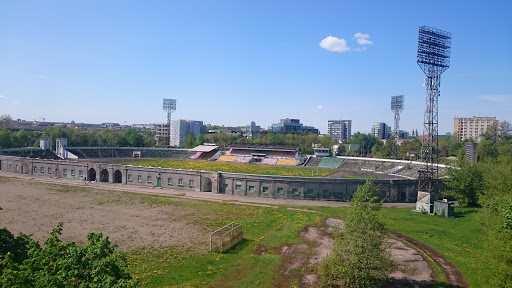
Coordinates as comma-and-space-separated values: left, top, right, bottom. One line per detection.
0, 0, 512, 134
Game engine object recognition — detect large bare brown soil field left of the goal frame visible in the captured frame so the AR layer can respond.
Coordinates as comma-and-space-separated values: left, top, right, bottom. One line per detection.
0, 178, 208, 251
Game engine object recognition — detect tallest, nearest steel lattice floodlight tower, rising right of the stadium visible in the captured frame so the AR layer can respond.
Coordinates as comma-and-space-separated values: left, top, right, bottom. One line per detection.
416, 26, 452, 199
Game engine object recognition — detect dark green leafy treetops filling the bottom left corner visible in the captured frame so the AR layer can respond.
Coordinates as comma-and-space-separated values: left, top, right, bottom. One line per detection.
0, 222, 137, 288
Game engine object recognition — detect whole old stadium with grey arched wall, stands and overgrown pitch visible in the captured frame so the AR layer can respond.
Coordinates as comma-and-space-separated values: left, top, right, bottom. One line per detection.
0, 139, 445, 203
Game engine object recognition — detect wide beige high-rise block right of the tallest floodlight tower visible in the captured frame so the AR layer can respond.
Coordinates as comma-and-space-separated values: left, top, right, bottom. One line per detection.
453, 116, 499, 142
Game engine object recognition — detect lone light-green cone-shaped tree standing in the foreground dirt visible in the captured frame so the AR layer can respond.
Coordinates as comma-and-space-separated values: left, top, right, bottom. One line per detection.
319, 179, 393, 287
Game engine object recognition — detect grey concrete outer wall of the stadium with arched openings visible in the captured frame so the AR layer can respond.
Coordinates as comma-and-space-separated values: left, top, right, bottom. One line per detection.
0, 156, 418, 202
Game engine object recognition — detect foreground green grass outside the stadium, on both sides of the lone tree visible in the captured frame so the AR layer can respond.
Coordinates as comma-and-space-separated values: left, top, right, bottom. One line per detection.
123, 191, 489, 288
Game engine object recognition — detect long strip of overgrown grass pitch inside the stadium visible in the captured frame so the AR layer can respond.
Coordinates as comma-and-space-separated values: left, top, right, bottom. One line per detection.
119, 160, 336, 177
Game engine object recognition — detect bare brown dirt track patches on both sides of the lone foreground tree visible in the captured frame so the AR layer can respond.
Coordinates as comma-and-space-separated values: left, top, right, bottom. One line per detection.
276, 219, 468, 288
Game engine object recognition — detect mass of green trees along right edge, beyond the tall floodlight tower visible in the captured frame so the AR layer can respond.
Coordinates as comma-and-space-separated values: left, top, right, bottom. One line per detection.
444, 125, 512, 287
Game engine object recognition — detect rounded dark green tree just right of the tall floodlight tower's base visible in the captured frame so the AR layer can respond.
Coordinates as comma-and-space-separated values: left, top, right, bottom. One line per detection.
443, 160, 485, 207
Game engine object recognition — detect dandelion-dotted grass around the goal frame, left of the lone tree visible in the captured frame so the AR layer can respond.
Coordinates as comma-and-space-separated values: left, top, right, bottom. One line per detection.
124, 197, 322, 287
